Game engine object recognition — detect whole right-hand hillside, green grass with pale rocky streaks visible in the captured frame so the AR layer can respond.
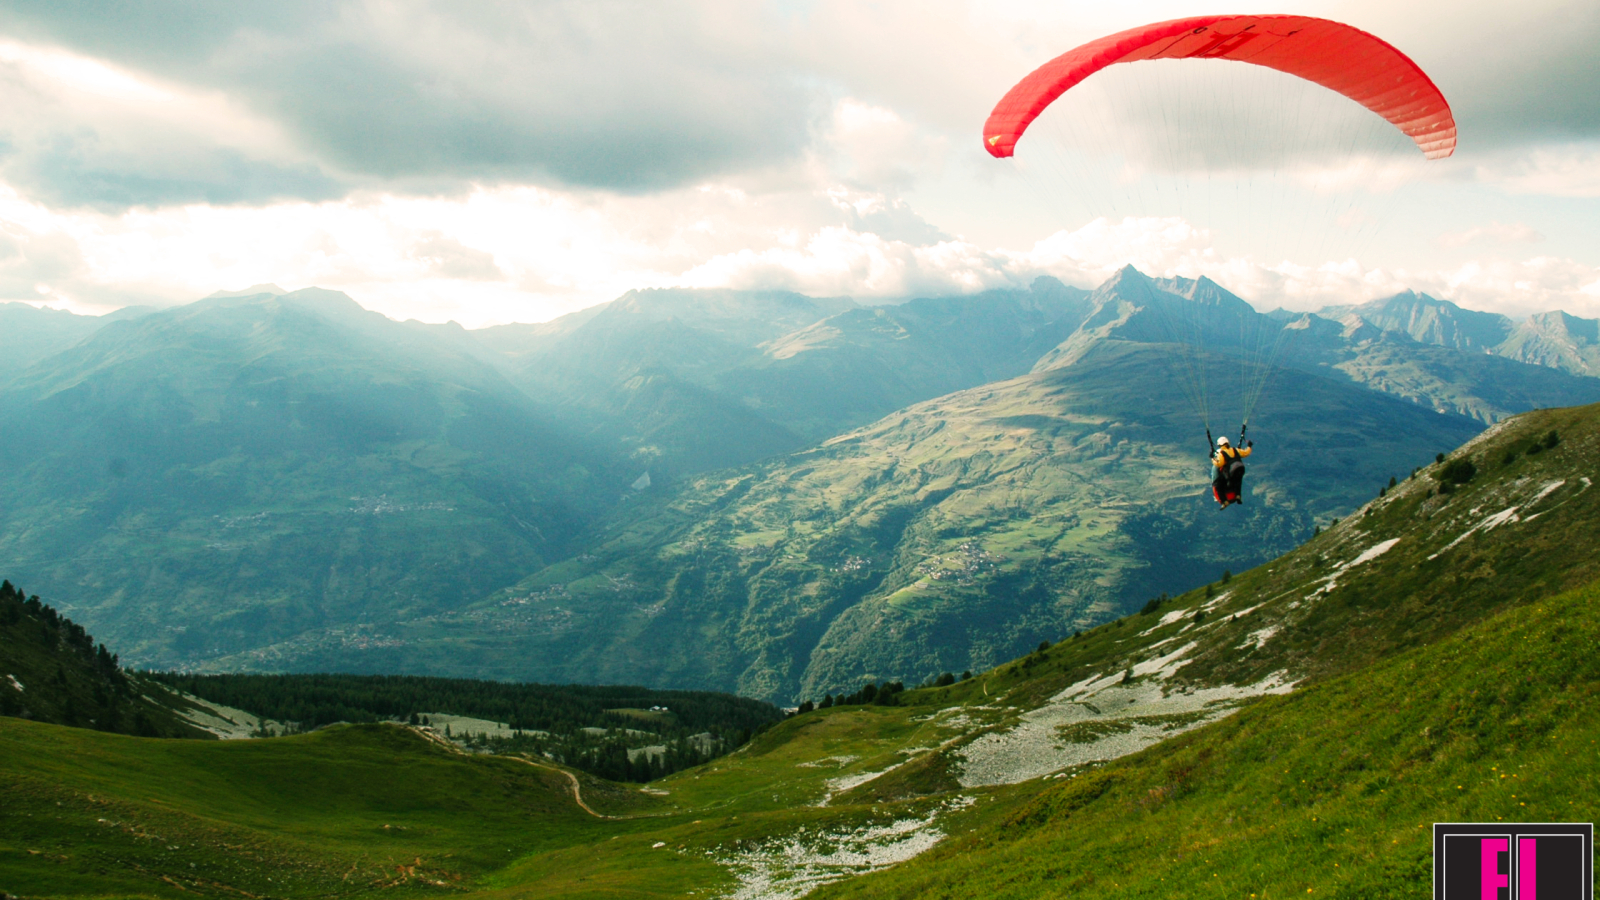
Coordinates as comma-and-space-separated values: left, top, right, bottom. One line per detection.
800, 398, 1600, 897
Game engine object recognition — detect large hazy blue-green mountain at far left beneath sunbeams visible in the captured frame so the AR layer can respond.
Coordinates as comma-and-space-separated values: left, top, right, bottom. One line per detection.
0, 290, 626, 665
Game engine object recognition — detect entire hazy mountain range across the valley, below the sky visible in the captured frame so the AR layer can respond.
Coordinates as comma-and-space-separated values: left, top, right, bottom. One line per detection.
0, 269, 1600, 700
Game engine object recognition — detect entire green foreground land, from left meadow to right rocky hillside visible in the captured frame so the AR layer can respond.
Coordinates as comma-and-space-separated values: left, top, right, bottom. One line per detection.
0, 392, 1600, 900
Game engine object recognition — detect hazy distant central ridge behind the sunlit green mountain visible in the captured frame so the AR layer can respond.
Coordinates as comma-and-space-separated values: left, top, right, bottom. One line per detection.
480, 279, 1082, 477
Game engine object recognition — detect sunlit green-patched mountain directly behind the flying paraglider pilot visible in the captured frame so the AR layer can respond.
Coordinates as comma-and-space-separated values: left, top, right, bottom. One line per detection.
222, 340, 1477, 700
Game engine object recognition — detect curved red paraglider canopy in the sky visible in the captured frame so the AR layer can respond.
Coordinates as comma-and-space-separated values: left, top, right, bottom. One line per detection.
984, 16, 1456, 160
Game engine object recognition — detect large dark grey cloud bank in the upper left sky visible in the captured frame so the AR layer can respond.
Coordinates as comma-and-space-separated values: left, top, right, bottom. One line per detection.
0, 0, 821, 203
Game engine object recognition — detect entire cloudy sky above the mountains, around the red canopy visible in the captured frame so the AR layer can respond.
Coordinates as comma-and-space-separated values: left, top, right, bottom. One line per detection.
0, 0, 1600, 327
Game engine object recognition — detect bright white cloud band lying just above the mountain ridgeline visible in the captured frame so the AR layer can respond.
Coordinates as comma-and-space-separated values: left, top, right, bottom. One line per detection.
0, 164, 1600, 327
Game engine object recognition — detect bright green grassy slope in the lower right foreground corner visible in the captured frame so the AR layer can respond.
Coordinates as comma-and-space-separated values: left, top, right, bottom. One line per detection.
814, 570, 1600, 900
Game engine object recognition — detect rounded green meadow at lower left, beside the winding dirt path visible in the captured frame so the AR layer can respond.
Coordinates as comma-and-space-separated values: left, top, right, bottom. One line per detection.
0, 719, 614, 897
